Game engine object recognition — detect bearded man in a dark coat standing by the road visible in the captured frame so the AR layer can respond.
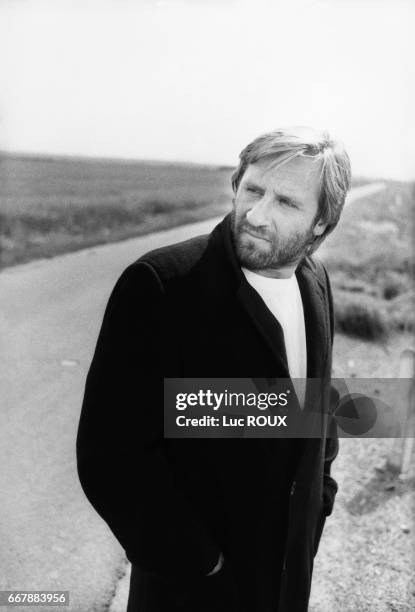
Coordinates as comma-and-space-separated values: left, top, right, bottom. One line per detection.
77, 128, 350, 612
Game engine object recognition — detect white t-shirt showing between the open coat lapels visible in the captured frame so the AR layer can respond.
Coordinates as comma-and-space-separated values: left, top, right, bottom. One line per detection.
242, 268, 307, 407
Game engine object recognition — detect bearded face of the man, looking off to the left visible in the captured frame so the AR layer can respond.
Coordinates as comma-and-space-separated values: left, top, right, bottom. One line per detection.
232, 157, 326, 276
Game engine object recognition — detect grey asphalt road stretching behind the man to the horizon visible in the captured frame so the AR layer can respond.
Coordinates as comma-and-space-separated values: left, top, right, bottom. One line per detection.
0, 184, 383, 612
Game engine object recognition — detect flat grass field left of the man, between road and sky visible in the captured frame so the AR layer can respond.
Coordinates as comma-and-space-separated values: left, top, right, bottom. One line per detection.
0, 156, 231, 268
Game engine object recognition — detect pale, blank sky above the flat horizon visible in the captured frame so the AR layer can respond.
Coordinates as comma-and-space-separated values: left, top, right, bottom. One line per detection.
0, 0, 415, 180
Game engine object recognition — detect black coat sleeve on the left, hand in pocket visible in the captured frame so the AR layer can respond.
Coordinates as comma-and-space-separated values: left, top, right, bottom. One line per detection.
76, 262, 220, 576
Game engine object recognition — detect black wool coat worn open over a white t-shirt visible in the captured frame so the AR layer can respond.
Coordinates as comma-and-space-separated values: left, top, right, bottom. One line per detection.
77, 215, 338, 612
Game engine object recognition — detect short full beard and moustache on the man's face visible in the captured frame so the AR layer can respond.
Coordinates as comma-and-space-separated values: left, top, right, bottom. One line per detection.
231, 209, 315, 270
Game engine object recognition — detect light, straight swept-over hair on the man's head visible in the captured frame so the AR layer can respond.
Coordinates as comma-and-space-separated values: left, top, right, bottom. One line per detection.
232, 127, 351, 254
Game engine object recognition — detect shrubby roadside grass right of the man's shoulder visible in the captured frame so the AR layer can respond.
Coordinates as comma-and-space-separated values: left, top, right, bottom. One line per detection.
323, 181, 415, 341
